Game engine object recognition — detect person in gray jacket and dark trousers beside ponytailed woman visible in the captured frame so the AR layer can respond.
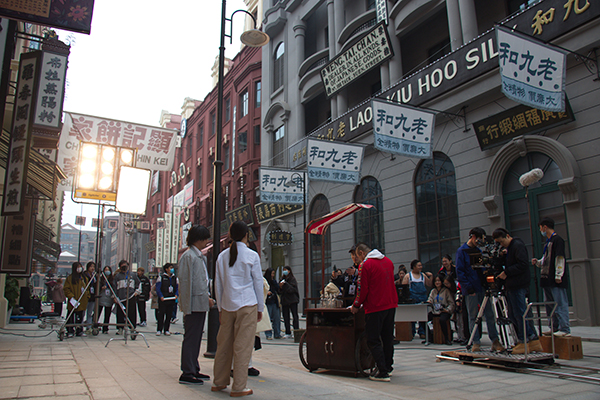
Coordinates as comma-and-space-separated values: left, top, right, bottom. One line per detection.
179, 225, 214, 385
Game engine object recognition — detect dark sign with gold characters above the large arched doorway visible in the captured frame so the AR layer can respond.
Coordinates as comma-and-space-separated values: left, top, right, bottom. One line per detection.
473, 99, 575, 150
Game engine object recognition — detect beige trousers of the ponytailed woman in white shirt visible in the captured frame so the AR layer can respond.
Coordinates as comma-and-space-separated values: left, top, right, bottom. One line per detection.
213, 305, 258, 391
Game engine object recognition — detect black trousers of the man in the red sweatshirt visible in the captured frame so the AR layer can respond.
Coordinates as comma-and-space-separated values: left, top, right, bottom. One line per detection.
365, 308, 396, 373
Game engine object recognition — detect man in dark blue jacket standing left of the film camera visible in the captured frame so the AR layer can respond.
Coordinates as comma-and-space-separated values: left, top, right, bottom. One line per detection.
456, 228, 504, 351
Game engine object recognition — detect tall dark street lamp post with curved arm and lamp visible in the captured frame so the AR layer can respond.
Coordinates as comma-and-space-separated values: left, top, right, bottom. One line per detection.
204, 0, 269, 358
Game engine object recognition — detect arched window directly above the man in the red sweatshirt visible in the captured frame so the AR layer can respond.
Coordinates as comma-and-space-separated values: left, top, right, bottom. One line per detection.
354, 176, 385, 253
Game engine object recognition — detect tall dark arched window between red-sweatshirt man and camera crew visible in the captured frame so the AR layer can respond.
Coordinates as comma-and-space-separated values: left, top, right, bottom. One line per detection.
415, 152, 460, 272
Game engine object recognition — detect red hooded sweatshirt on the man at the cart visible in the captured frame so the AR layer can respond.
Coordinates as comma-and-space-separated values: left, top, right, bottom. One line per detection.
354, 249, 398, 314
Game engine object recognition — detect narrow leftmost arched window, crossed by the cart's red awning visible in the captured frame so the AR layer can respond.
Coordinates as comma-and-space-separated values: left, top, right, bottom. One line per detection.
307, 194, 331, 297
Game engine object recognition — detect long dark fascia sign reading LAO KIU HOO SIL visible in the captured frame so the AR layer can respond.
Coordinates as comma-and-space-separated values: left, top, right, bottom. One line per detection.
310, 0, 600, 142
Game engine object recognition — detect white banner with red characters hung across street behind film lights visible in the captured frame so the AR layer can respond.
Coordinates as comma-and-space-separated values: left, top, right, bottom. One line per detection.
57, 112, 177, 190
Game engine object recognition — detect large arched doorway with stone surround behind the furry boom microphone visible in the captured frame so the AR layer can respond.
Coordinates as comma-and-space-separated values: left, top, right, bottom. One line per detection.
502, 152, 570, 301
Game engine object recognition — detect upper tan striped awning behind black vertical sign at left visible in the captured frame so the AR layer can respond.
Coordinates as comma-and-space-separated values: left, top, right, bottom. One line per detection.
0, 129, 67, 200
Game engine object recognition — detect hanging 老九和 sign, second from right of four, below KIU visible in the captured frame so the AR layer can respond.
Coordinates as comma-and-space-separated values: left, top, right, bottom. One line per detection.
371, 99, 435, 158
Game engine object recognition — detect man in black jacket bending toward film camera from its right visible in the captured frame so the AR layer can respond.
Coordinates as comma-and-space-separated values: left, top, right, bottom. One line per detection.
492, 228, 543, 354
